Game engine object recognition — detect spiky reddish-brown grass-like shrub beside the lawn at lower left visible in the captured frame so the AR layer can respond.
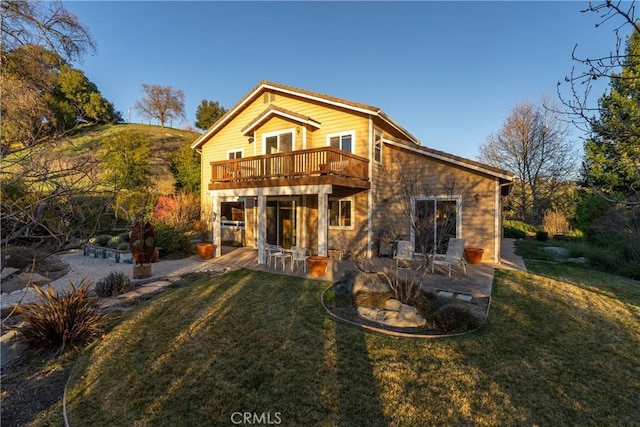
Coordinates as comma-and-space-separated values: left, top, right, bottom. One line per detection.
12, 280, 106, 354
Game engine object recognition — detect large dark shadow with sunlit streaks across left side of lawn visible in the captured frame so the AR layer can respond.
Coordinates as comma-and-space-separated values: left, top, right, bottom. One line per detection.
63, 270, 387, 426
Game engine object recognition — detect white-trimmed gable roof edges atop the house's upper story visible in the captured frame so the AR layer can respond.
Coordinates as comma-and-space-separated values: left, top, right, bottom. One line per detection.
191, 80, 420, 148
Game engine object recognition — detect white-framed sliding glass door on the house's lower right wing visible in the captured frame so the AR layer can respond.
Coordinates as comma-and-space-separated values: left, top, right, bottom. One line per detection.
411, 196, 461, 253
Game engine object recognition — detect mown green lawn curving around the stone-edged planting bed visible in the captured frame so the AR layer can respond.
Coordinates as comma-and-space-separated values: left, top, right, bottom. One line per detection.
67, 266, 640, 426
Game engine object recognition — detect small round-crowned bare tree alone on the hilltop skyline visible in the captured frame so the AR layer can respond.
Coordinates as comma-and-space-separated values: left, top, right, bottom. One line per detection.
135, 83, 184, 127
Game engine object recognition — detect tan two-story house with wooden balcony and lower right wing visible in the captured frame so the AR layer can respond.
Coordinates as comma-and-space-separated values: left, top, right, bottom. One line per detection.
192, 81, 513, 263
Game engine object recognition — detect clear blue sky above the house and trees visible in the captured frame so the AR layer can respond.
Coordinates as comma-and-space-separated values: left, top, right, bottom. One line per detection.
65, 1, 615, 158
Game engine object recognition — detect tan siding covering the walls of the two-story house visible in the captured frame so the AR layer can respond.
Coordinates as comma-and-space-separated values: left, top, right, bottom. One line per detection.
202, 85, 499, 261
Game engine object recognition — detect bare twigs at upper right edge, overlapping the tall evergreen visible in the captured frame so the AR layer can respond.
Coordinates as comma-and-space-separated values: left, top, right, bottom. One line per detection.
557, 0, 640, 205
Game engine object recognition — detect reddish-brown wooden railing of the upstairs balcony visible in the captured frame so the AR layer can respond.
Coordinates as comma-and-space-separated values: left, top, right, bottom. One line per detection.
211, 147, 369, 183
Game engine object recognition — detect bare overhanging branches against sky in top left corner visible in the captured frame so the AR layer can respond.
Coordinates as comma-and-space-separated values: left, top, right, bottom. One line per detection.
0, 0, 95, 60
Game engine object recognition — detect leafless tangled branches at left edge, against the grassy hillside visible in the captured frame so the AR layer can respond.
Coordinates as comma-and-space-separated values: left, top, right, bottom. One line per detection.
0, 140, 114, 250
